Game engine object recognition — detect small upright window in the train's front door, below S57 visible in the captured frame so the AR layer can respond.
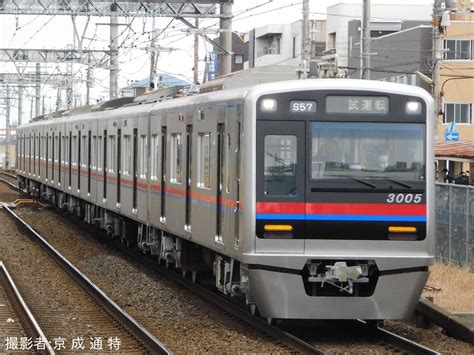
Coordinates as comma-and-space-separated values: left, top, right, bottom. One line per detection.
264, 135, 297, 197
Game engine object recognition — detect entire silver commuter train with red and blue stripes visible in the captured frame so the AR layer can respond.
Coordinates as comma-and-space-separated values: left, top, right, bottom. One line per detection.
17, 79, 434, 320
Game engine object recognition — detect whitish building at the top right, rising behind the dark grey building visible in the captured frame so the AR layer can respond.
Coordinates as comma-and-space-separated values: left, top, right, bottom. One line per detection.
326, 0, 433, 66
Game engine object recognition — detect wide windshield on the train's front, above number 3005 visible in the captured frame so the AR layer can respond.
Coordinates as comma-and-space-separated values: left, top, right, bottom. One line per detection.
311, 122, 425, 184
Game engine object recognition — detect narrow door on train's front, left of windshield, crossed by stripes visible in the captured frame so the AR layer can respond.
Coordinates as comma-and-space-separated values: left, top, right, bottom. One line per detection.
256, 121, 306, 253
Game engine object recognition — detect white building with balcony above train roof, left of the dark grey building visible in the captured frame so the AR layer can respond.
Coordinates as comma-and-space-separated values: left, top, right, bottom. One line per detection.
244, 21, 326, 69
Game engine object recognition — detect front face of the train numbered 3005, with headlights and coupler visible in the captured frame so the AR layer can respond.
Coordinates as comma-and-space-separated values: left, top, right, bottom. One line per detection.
243, 80, 434, 320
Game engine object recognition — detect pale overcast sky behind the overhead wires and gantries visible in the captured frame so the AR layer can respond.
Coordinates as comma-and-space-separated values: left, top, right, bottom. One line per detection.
0, 0, 433, 127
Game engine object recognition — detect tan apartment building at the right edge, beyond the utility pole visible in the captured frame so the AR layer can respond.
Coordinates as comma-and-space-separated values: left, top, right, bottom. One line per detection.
436, 0, 474, 183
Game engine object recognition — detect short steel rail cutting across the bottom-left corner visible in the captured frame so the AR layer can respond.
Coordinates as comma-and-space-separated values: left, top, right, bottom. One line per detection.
0, 261, 56, 355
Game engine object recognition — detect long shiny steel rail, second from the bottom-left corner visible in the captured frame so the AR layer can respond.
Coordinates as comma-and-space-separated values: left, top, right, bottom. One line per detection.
3, 203, 172, 354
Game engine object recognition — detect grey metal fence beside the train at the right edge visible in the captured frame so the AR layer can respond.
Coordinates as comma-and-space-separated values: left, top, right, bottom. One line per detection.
436, 184, 474, 269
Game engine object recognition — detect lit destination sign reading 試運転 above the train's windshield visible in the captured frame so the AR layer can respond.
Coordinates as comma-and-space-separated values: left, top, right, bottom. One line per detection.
326, 95, 388, 114
